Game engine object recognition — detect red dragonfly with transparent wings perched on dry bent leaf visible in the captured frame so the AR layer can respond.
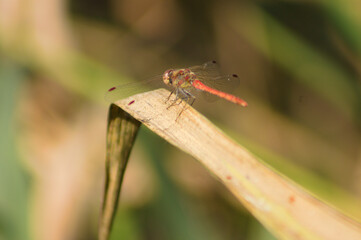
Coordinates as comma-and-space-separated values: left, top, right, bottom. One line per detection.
106, 61, 248, 117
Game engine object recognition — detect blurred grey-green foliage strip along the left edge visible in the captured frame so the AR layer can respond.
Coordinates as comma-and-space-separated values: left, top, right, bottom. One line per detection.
0, 59, 29, 239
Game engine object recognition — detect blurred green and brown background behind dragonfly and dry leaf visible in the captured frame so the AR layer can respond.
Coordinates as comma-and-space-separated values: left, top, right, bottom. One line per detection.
0, 0, 361, 240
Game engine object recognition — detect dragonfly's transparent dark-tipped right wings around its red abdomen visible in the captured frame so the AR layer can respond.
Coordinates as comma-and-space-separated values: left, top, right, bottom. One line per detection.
189, 61, 240, 101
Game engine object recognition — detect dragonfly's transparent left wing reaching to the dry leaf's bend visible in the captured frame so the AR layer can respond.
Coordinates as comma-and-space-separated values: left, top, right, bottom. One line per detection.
104, 75, 167, 102
